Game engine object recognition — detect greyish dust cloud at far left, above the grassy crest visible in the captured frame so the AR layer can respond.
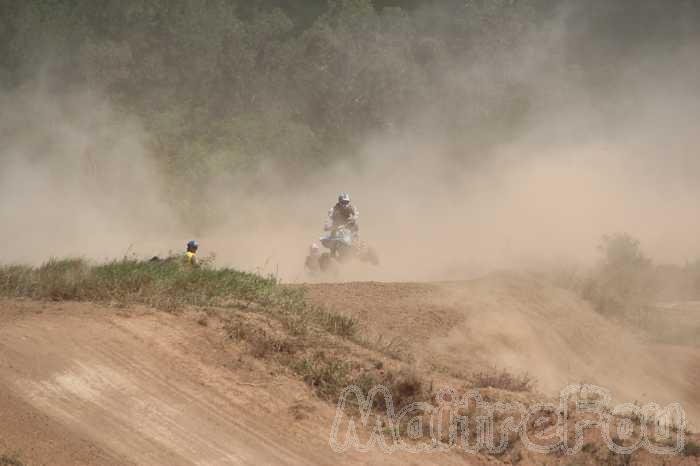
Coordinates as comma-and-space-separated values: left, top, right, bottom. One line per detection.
0, 83, 174, 264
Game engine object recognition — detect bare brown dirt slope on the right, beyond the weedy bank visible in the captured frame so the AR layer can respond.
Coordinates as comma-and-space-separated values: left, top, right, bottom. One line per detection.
309, 273, 700, 429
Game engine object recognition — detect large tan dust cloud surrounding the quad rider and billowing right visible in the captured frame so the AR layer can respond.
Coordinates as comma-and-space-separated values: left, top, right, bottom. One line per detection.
204, 72, 700, 281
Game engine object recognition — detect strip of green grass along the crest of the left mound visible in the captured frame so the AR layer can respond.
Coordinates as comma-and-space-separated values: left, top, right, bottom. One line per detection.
0, 257, 357, 337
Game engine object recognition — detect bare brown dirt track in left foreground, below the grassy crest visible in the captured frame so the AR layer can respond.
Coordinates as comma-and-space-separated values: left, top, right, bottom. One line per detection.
0, 301, 477, 466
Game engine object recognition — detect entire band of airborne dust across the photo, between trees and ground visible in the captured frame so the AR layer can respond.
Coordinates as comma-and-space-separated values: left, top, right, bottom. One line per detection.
0, 2, 700, 281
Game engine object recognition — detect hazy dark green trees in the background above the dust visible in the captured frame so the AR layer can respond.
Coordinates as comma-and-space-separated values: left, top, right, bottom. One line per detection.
0, 0, 700, 222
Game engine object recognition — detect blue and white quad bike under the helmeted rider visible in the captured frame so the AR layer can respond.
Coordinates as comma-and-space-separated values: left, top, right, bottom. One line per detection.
306, 224, 379, 273
